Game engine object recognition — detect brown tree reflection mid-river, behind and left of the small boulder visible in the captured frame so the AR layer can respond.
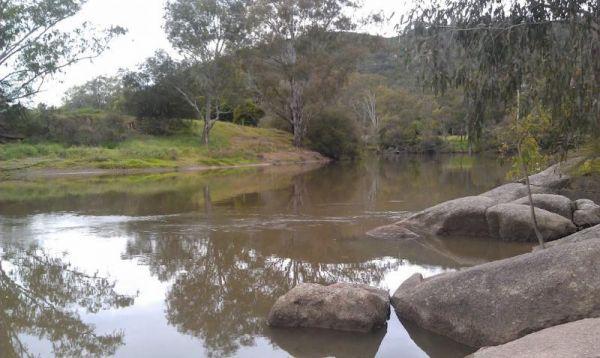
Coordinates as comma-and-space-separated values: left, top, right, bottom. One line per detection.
127, 227, 400, 356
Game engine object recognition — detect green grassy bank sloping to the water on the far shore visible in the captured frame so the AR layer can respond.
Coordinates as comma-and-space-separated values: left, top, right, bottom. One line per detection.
0, 122, 296, 171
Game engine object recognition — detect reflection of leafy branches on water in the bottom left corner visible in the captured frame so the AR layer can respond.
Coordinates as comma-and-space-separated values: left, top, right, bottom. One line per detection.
0, 247, 133, 357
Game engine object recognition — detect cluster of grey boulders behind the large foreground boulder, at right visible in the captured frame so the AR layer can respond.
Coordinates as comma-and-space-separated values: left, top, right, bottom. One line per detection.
367, 165, 600, 242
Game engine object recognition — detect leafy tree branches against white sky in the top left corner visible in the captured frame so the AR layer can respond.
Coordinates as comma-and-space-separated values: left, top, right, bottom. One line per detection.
0, 0, 125, 107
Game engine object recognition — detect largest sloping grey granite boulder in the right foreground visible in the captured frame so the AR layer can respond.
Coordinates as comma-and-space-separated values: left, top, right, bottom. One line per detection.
392, 236, 600, 347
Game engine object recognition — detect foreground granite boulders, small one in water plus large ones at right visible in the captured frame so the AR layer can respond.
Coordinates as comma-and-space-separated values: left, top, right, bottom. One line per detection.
268, 225, 600, 358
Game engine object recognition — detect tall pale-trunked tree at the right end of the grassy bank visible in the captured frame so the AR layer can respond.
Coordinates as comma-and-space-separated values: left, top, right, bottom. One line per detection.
249, 0, 358, 147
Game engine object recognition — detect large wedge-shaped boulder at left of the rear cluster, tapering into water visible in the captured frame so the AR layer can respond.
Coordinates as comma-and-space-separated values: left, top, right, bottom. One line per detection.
401, 196, 495, 236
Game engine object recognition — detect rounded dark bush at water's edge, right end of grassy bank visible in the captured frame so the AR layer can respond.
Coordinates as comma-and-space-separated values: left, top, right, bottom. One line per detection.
308, 109, 360, 160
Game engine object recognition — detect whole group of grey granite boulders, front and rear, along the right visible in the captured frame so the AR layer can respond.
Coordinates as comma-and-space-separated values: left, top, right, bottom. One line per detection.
268, 161, 600, 358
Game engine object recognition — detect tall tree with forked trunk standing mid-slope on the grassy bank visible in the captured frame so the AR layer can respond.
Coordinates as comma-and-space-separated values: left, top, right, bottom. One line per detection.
165, 0, 248, 145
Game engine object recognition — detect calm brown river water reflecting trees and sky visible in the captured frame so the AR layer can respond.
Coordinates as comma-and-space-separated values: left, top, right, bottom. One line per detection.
0, 157, 528, 357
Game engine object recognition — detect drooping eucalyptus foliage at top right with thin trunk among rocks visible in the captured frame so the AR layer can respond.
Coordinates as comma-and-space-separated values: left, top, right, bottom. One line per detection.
404, 0, 600, 245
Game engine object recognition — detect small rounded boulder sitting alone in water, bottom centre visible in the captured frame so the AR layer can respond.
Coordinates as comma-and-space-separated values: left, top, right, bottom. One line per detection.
267, 283, 390, 332
